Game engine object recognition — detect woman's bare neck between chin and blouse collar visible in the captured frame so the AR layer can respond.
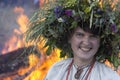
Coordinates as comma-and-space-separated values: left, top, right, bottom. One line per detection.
73, 58, 94, 68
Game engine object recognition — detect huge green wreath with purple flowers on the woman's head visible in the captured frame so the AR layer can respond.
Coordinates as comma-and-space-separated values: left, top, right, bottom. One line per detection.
26, 0, 120, 67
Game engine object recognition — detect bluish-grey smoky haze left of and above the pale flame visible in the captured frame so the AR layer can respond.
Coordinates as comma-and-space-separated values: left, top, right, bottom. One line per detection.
0, 0, 39, 55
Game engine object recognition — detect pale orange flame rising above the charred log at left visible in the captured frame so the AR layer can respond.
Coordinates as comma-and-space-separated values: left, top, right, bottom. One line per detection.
1, 7, 28, 54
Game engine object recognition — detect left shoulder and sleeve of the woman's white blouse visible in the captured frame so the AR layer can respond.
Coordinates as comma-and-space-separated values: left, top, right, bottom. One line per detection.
44, 58, 72, 80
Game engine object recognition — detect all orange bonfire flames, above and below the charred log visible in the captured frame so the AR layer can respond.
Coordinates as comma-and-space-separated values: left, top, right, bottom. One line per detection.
2, 0, 120, 80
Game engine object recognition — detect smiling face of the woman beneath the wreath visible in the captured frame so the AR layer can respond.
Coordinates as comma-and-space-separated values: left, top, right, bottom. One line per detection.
69, 27, 100, 60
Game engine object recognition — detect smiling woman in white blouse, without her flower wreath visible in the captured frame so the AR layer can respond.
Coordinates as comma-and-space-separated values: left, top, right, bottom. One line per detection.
44, 22, 120, 80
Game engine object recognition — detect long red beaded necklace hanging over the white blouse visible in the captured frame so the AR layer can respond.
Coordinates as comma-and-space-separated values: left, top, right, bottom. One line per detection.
66, 60, 95, 80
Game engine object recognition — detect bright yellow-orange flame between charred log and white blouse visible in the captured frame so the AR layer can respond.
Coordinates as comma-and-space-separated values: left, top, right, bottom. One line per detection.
24, 38, 61, 80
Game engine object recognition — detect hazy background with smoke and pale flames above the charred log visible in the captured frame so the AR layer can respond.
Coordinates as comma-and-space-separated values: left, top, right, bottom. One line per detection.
0, 0, 40, 55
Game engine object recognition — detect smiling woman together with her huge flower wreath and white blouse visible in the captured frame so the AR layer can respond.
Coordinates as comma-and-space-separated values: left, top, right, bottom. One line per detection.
27, 0, 120, 80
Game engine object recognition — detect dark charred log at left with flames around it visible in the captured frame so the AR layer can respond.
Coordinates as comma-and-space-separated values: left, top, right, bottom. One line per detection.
0, 46, 38, 80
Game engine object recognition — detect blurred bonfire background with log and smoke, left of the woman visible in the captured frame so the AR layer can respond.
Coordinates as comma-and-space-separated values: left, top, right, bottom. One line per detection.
0, 0, 59, 80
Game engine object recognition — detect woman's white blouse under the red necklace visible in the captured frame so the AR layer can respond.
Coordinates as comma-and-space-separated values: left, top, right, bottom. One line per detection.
44, 58, 120, 80
